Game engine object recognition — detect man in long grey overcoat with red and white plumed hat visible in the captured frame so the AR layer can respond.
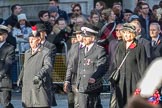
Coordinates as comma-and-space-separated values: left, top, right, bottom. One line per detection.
17, 28, 53, 108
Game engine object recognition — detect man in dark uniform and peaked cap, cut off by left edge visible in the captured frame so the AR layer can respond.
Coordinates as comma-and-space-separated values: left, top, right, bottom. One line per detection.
0, 25, 15, 108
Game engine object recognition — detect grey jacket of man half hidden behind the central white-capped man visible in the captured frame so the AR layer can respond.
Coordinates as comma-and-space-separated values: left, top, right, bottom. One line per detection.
65, 42, 79, 85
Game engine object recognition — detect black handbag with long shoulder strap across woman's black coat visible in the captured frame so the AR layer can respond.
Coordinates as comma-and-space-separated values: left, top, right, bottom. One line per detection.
109, 51, 130, 84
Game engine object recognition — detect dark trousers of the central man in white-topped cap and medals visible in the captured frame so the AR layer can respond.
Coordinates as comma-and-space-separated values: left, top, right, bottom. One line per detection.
79, 93, 102, 108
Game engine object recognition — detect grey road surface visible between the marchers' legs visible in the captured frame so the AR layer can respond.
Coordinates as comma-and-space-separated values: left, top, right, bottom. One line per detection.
7, 92, 109, 108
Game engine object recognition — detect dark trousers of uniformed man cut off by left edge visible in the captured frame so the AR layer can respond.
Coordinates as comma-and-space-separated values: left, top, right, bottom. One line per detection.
0, 90, 14, 108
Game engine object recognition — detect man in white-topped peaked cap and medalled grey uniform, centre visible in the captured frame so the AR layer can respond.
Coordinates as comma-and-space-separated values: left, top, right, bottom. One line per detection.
77, 24, 107, 108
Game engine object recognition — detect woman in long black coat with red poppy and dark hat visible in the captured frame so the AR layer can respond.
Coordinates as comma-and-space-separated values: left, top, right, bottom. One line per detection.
110, 23, 147, 108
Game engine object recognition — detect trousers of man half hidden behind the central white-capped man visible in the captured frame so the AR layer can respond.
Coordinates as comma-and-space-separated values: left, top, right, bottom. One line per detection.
68, 85, 79, 108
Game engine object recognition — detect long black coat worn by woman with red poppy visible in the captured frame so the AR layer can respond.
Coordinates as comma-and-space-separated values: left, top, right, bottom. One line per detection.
115, 41, 147, 108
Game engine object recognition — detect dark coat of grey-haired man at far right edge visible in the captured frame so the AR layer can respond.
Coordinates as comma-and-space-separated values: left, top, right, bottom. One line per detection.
151, 36, 162, 60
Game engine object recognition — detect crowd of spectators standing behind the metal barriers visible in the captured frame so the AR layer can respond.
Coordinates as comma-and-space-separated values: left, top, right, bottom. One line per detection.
1, 0, 162, 54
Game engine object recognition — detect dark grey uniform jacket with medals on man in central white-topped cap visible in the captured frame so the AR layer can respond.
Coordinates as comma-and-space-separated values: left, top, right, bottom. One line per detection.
77, 43, 107, 93
